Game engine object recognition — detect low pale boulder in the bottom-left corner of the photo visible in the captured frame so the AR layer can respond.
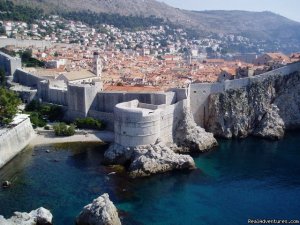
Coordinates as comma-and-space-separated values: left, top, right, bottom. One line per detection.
0, 207, 53, 225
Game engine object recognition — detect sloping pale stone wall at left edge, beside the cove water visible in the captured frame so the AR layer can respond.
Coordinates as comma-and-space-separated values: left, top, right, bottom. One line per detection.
0, 115, 35, 168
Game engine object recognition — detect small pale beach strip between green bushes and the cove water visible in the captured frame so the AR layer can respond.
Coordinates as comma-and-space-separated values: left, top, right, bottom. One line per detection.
28, 129, 114, 146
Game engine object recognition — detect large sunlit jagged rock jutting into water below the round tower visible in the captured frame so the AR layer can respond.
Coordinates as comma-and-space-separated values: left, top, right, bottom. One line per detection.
129, 142, 196, 177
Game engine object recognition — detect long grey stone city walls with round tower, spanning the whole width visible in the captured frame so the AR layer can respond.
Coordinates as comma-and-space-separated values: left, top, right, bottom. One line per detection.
0, 50, 300, 140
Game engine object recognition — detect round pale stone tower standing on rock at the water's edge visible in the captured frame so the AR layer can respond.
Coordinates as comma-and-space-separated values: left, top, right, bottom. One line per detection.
114, 100, 161, 147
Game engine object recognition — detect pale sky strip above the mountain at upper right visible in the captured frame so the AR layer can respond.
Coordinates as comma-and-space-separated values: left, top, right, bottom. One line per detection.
159, 0, 300, 22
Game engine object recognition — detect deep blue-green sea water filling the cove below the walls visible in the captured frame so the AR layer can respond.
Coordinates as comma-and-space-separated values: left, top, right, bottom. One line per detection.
0, 132, 300, 225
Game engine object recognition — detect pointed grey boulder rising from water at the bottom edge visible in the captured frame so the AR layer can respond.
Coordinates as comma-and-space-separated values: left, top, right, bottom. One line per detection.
76, 193, 121, 225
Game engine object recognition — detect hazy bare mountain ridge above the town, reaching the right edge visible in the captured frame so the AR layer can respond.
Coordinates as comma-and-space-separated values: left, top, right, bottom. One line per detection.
8, 0, 300, 43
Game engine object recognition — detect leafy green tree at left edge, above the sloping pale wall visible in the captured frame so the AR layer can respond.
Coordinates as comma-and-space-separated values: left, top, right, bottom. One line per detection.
0, 87, 21, 124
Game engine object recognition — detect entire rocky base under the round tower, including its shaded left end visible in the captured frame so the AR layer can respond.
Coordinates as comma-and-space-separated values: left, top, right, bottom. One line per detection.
104, 140, 196, 178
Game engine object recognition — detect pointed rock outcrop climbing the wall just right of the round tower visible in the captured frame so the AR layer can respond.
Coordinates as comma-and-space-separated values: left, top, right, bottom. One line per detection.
174, 109, 218, 152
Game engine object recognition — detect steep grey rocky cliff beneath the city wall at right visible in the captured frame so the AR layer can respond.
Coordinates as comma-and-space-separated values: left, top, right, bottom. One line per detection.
205, 72, 300, 139
